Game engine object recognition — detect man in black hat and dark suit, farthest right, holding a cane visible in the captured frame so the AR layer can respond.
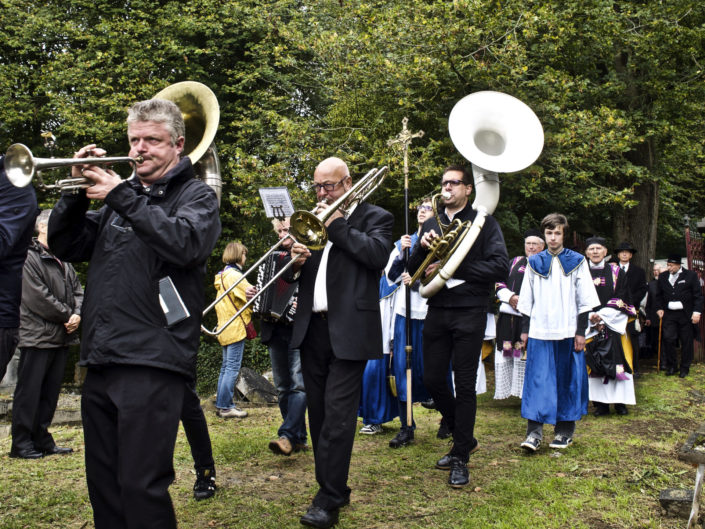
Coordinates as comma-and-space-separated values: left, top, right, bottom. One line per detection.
655, 255, 703, 378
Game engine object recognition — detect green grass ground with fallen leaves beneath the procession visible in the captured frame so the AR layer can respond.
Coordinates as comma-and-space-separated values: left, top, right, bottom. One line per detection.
0, 365, 705, 529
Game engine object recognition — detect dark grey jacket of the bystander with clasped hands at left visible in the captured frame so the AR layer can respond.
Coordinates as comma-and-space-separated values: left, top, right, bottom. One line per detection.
19, 239, 83, 349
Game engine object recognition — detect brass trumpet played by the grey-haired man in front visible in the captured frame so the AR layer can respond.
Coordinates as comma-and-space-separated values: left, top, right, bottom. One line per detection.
5, 143, 143, 191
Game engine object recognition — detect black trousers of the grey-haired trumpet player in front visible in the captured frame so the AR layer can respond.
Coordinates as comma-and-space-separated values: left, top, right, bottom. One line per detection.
81, 366, 187, 529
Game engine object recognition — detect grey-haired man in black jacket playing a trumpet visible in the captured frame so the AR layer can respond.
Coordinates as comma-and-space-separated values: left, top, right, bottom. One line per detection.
49, 99, 220, 529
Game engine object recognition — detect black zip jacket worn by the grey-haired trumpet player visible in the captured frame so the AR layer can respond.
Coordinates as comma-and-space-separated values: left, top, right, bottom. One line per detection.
49, 158, 220, 377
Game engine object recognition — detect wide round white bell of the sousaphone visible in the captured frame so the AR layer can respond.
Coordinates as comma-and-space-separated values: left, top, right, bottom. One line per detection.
448, 91, 543, 173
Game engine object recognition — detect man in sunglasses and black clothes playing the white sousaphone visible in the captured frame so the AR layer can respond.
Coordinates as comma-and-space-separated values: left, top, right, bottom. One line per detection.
409, 165, 509, 488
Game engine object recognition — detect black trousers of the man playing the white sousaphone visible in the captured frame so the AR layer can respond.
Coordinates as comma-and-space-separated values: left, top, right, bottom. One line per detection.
423, 307, 487, 461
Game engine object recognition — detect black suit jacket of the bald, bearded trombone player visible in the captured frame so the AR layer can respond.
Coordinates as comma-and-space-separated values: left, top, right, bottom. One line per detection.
290, 202, 394, 360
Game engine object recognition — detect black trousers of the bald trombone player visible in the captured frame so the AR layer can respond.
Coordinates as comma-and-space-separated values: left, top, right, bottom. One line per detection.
301, 314, 367, 510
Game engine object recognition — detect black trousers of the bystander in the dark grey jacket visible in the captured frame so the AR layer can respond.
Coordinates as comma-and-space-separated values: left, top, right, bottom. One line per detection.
12, 347, 68, 451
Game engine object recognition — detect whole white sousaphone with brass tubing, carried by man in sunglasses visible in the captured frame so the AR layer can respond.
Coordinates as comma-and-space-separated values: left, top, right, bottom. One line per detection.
415, 91, 543, 297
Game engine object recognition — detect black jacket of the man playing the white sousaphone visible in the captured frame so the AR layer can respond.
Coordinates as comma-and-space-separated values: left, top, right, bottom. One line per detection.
409, 202, 509, 308
